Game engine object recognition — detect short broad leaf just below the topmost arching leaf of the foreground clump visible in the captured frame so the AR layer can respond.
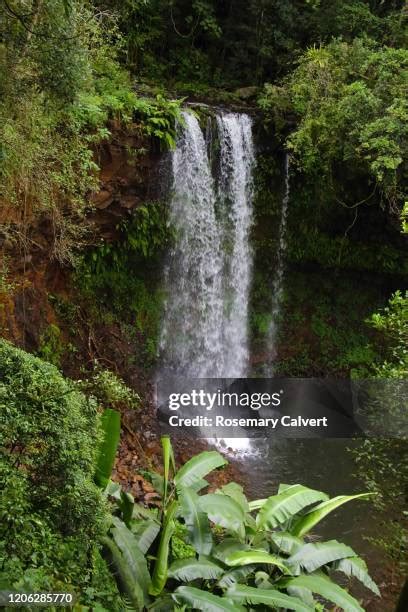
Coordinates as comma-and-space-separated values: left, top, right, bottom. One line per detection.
199, 493, 245, 538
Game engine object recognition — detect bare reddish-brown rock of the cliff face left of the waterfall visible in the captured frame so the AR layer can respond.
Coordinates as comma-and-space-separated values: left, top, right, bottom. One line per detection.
0, 122, 162, 364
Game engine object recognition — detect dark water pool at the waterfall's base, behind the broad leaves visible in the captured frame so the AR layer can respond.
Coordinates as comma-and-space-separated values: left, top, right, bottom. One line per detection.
218, 439, 380, 564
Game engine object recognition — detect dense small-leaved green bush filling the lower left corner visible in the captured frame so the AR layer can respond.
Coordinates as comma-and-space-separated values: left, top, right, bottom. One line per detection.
0, 340, 118, 605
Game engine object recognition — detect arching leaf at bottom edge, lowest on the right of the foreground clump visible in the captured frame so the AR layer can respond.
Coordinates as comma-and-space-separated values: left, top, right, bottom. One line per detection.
279, 575, 364, 612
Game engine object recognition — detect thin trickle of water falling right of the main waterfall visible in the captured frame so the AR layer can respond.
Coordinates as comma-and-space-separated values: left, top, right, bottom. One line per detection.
267, 153, 290, 376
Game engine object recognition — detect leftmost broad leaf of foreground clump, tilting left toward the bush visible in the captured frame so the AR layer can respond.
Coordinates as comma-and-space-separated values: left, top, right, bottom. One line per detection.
111, 517, 150, 602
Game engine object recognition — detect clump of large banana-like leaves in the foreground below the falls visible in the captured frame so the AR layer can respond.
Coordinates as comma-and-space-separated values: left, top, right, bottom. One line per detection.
106, 438, 379, 611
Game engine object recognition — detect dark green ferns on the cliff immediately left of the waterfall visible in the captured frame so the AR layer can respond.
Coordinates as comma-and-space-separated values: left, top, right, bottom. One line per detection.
75, 202, 167, 367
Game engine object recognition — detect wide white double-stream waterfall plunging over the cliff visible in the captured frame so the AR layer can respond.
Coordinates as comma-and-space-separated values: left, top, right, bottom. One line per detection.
160, 111, 254, 378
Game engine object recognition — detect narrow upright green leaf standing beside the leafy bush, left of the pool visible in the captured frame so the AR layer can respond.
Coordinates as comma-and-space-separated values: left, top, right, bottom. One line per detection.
95, 408, 120, 489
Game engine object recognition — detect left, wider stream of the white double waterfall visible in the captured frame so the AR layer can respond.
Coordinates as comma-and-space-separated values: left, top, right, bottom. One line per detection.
161, 112, 223, 378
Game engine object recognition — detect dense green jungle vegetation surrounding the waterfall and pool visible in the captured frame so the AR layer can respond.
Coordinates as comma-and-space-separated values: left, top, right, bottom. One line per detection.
0, 0, 408, 612
